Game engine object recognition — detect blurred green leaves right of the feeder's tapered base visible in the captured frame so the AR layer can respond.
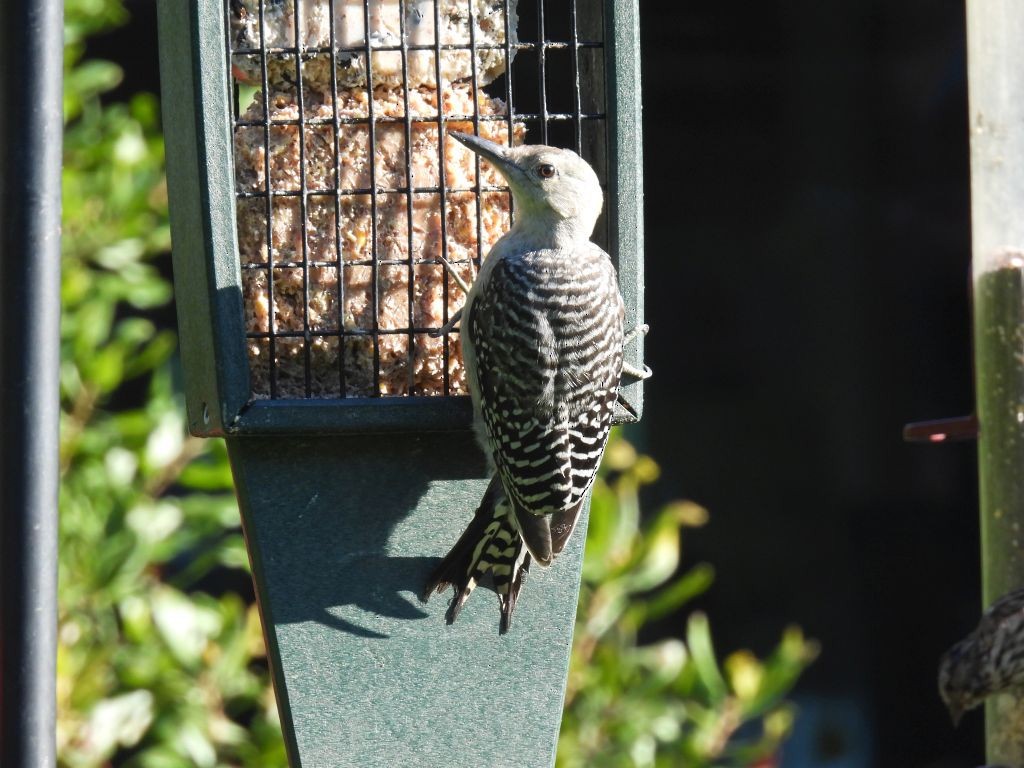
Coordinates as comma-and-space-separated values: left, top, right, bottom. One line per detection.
557, 435, 817, 768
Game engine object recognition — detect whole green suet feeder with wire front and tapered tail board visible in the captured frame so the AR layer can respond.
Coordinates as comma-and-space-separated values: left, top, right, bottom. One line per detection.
160, 0, 643, 768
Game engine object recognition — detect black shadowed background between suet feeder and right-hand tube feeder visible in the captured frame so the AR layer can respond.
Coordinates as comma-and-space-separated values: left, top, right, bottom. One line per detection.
99, 0, 983, 768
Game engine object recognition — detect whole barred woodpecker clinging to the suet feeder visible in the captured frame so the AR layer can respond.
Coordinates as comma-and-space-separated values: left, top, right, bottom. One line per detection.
424, 133, 649, 632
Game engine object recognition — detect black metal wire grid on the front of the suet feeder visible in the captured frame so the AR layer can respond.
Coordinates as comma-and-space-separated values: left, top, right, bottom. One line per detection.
224, 0, 609, 399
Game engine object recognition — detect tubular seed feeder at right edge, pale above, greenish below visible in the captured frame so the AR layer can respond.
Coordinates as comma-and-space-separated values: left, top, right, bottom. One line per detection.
967, 0, 1024, 765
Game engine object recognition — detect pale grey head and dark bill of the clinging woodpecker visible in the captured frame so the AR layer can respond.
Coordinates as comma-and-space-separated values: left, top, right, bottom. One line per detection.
452, 131, 604, 246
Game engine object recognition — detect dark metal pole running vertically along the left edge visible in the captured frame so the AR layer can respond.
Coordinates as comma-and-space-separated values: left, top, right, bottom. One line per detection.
0, 0, 63, 768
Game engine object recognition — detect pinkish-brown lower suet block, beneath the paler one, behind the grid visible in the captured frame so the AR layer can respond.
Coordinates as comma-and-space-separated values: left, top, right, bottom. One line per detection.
234, 81, 524, 397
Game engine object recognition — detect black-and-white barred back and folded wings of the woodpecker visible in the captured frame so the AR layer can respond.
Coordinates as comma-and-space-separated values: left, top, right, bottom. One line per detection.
469, 244, 623, 564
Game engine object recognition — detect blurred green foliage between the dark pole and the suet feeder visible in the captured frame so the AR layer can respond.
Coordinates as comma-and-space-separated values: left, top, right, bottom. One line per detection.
57, 0, 285, 768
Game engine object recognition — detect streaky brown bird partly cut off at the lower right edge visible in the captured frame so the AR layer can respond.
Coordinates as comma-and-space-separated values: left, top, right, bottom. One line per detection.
939, 590, 1024, 723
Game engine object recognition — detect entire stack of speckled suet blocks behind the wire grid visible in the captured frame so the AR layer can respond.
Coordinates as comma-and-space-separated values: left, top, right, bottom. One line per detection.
230, 0, 525, 398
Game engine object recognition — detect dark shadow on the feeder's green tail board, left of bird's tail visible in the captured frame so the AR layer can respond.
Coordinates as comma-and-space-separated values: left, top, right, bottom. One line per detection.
228, 433, 484, 638
